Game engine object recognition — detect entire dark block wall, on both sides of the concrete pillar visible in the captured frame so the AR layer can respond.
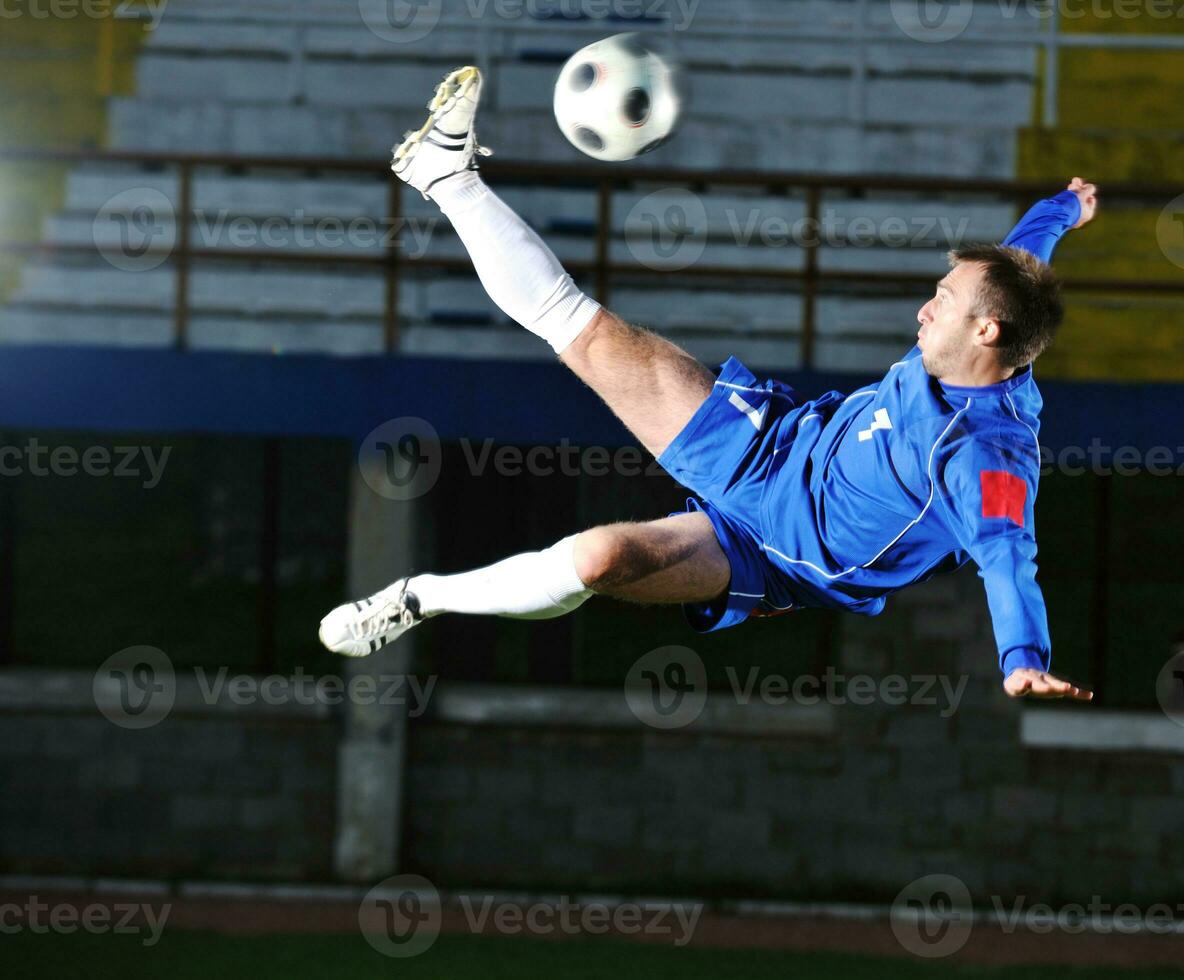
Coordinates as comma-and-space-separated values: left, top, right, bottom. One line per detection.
0, 569, 1184, 904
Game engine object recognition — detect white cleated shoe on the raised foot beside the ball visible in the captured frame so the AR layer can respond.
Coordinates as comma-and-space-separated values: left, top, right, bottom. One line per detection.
391, 65, 491, 199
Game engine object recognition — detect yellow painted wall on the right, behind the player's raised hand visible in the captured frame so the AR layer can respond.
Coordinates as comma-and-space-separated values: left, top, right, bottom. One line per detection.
1017, 6, 1184, 381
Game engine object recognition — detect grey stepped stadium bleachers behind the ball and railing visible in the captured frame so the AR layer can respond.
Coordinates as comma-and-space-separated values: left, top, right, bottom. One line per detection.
0, 0, 1036, 370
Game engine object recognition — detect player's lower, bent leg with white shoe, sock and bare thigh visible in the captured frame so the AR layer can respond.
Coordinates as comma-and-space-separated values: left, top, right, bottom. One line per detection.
321, 514, 731, 657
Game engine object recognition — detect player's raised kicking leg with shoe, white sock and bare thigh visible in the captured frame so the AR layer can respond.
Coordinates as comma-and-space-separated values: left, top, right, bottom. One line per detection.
394, 69, 714, 454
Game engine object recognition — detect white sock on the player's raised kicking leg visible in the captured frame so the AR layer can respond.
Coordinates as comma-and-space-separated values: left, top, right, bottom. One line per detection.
431, 170, 600, 354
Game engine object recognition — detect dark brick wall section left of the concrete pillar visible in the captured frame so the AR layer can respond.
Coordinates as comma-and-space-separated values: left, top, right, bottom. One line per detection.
0, 714, 336, 881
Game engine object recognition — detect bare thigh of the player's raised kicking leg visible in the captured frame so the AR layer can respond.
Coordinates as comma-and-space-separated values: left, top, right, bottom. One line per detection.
561, 310, 715, 456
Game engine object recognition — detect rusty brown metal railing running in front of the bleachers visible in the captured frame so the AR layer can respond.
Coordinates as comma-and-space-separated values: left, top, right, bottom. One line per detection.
0, 150, 1184, 368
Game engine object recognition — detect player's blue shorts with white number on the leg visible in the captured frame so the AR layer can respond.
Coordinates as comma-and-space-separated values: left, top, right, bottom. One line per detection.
658, 357, 806, 633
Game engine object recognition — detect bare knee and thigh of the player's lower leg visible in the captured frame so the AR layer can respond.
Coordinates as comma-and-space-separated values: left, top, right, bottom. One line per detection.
575, 512, 732, 602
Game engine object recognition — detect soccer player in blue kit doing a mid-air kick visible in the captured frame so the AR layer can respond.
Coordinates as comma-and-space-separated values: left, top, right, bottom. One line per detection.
320, 67, 1096, 701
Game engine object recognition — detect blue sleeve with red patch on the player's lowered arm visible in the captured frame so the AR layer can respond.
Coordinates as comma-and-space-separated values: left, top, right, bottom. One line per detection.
940, 438, 1051, 677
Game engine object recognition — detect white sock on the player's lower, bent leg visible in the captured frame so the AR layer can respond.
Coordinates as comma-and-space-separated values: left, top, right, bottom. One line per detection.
407, 535, 592, 619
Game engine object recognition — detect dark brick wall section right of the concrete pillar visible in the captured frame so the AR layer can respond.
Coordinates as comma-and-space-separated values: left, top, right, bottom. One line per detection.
404, 569, 1184, 904
